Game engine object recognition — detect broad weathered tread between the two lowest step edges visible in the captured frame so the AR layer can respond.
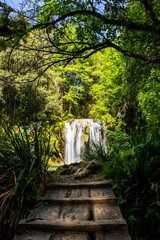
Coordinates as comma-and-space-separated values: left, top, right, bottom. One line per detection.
26, 202, 122, 222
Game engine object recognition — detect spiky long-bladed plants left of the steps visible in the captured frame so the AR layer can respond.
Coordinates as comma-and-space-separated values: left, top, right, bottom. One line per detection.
0, 125, 53, 239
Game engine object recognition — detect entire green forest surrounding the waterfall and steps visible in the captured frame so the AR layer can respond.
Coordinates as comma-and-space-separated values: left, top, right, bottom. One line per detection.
0, 0, 160, 240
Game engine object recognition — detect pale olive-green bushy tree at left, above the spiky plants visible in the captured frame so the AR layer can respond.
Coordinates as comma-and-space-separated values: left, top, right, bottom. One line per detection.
0, 36, 61, 124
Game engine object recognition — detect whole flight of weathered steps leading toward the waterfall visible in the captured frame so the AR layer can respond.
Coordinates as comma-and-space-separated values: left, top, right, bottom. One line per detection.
14, 181, 131, 240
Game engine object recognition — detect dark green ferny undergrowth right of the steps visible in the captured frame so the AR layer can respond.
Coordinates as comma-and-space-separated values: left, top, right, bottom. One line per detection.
103, 131, 160, 240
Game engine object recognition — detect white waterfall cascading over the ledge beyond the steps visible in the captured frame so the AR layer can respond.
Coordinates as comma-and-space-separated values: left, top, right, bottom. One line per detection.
65, 119, 106, 164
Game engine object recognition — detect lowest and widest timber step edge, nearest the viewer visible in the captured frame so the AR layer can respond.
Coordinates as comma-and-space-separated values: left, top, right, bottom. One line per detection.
18, 219, 128, 233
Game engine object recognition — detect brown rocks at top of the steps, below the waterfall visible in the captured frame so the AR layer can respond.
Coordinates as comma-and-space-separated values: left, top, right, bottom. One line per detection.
56, 160, 101, 179
